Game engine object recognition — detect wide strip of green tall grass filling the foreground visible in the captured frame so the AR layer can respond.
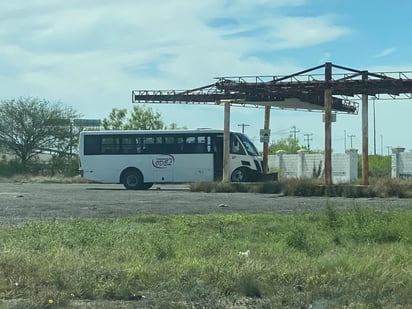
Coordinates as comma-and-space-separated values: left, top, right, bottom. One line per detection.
0, 204, 412, 308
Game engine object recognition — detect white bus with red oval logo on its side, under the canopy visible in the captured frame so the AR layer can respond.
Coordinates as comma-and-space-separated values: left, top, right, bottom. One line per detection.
79, 129, 262, 190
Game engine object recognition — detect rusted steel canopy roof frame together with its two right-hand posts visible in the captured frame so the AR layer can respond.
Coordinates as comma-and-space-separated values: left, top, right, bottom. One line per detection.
132, 62, 412, 184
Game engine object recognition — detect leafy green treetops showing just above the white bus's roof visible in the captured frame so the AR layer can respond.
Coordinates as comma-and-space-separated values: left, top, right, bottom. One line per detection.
102, 105, 164, 130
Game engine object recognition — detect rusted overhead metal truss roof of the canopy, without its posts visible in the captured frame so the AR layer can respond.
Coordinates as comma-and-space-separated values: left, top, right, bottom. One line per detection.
132, 63, 412, 114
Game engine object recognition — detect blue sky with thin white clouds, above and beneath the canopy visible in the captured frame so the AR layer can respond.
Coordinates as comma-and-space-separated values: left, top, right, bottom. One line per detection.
0, 0, 412, 154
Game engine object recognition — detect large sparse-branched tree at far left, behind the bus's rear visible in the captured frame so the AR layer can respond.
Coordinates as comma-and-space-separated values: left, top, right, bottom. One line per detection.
0, 97, 78, 164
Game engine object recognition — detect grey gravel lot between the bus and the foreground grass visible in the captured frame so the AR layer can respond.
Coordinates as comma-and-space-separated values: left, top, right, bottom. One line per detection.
0, 183, 412, 226
